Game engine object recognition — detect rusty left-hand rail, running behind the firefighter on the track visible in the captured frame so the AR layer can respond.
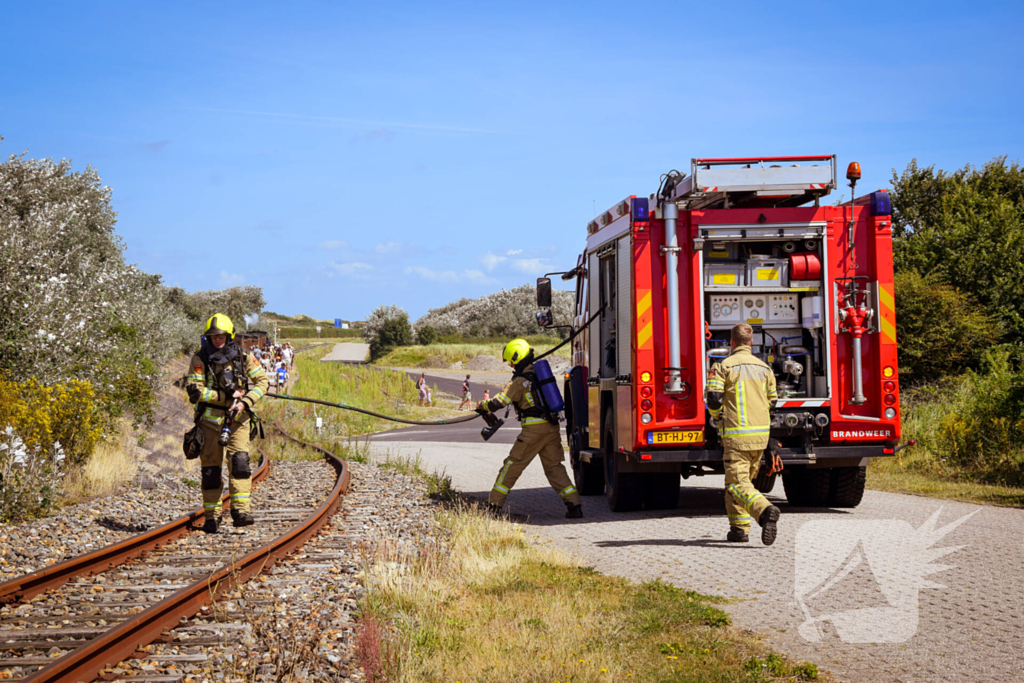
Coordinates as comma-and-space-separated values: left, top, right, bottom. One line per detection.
0, 457, 270, 604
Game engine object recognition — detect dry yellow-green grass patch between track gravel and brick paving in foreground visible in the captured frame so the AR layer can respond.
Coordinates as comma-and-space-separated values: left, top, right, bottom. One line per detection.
356, 505, 818, 683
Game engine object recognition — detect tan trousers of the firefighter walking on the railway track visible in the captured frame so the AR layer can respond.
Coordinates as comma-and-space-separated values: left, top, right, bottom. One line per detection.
199, 420, 252, 518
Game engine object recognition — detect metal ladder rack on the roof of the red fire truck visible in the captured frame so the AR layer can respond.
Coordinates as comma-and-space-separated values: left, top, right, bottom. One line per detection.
662, 155, 837, 210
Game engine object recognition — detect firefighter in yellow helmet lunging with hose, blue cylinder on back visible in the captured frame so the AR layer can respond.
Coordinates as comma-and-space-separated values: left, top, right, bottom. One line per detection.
476, 339, 583, 519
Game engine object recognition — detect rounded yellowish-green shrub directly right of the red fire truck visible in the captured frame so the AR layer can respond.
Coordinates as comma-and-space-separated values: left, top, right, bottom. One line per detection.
896, 270, 999, 382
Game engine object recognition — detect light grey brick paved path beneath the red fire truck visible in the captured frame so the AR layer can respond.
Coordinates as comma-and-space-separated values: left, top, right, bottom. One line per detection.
376, 441, 1024, 683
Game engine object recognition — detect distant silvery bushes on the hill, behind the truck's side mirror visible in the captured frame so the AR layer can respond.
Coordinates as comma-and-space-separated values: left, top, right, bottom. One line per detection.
415, 285, 574, 338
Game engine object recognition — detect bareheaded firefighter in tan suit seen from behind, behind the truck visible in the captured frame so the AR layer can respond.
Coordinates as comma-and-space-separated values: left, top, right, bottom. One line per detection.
707, 323, 779, 546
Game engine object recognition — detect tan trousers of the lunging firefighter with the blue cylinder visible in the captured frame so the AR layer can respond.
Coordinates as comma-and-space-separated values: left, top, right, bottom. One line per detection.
487, 423, 581, 507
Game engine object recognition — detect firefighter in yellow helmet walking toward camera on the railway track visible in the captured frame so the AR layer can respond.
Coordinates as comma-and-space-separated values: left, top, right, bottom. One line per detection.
185, 313, 270, 533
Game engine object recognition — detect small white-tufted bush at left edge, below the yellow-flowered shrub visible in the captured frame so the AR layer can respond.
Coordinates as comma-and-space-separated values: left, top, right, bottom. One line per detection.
0, 425, 66, 523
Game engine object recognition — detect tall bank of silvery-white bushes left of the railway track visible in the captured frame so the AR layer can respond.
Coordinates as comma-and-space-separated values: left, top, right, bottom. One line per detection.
0, 151, 263, 425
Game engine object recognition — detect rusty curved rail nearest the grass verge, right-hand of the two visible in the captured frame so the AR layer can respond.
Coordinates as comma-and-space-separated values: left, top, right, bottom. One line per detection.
23, 423, 351, 683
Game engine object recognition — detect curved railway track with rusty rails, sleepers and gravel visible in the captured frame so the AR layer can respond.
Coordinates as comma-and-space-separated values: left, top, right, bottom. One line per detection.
0, 425, 350, 683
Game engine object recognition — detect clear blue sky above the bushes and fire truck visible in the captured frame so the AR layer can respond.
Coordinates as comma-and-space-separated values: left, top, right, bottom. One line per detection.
0, 2, 1024, 319
